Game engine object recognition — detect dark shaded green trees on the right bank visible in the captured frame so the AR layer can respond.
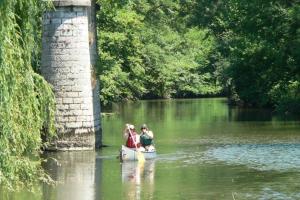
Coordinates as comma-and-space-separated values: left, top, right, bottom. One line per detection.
183, 0, 300, 112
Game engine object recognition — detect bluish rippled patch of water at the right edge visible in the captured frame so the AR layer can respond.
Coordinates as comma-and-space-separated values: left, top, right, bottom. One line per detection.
204, 144, 300, 171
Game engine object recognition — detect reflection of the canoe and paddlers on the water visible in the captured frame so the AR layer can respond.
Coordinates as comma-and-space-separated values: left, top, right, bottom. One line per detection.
122, 160, 155, 200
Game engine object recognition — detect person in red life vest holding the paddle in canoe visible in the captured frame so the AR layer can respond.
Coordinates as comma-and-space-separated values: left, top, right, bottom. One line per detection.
124, 124, 141, 148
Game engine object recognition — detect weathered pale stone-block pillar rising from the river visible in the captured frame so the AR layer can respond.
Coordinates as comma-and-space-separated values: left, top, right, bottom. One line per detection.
41, 0, 101, 150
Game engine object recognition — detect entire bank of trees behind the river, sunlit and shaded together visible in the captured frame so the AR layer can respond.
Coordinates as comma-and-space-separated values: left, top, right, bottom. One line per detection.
98, 0, 300, 111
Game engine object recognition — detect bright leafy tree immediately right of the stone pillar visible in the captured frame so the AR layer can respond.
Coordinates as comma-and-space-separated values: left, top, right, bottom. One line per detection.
97, 1, 145, 104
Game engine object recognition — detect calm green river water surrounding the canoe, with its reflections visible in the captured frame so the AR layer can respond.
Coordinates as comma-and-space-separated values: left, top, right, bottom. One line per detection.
3, 98, 300, 200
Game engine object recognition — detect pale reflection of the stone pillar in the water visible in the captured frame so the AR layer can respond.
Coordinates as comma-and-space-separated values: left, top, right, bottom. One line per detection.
43, 151, 101, 200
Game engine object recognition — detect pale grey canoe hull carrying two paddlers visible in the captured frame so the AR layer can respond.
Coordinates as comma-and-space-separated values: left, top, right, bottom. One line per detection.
120, 145, 156, 161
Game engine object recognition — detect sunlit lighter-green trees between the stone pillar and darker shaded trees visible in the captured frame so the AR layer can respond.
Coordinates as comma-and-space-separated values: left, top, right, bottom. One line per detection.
97, 0, 222, 104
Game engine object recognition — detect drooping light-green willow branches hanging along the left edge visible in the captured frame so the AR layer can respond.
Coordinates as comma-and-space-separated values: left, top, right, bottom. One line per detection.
0, 0, 55, 188
